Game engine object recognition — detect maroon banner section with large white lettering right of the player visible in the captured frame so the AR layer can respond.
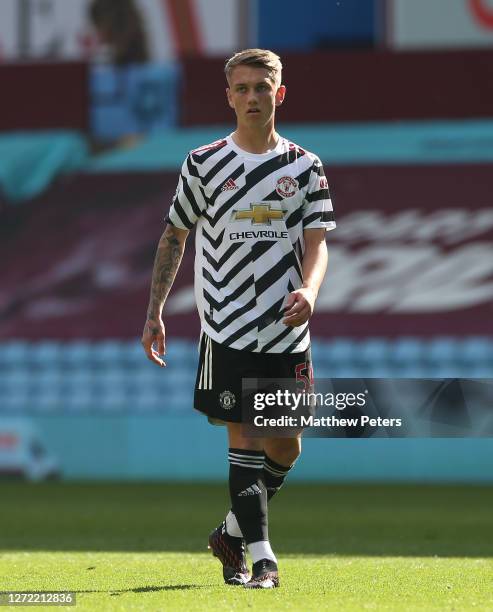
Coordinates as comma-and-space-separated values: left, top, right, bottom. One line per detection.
312, 164, 493, 337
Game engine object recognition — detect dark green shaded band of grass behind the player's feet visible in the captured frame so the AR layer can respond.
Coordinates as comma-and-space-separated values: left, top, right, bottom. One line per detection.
0, 483, 493, 560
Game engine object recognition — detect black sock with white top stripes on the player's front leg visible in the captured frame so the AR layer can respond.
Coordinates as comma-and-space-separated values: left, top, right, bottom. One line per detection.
228, 448, 269, 544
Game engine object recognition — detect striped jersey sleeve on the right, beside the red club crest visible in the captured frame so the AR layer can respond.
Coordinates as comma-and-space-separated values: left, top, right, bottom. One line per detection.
303, 156, 336, 231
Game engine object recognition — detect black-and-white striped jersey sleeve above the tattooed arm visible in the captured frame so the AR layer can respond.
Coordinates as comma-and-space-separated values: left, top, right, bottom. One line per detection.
166, 155, 206, 230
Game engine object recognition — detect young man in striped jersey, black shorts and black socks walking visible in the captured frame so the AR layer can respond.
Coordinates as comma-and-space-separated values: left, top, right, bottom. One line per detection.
142, 49, 335, 588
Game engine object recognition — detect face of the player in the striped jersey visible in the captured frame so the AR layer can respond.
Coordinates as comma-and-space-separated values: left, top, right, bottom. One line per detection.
226, 66, 286, 126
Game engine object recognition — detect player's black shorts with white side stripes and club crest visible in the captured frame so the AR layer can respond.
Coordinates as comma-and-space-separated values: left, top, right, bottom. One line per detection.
194, 333, 313, 424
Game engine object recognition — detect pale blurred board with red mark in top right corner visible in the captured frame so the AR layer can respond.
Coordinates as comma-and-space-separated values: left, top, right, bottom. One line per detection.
386, 0, 493, 49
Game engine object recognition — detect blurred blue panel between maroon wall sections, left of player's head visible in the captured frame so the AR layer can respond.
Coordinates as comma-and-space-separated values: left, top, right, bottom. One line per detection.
90, 63, 178, 141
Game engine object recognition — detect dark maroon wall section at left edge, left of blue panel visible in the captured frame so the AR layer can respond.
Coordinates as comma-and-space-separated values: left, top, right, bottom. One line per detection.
0, 62, 89, 131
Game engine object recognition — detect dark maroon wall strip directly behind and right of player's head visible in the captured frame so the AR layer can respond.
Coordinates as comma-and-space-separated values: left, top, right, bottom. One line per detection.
181, 50, 493, 126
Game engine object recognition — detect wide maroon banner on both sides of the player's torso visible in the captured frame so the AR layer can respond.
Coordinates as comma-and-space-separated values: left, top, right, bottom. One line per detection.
0, 165, 493, 339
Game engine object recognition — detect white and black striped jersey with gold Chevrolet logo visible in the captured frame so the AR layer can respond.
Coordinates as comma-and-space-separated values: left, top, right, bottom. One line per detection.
166, 136, 335, 353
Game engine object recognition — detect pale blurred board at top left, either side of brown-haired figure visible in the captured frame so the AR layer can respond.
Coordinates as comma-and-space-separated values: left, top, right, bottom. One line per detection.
0, 0, 244, 62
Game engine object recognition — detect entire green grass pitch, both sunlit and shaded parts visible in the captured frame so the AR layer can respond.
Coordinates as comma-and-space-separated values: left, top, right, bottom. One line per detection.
0, 483, 493, 611
